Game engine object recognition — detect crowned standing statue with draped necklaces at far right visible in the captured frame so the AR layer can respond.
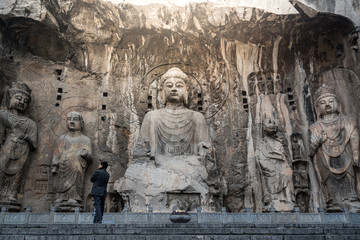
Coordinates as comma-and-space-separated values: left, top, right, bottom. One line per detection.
310, 84, 360, 211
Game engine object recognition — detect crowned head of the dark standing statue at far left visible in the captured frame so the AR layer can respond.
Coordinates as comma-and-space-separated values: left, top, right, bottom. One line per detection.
7, 83, 31, 112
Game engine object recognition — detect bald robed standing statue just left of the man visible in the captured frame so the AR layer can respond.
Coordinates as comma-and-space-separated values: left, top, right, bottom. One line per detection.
51, 112, 91, 211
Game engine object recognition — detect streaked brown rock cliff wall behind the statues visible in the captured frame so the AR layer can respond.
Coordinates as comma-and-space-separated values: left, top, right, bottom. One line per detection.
0, 0, 360, 212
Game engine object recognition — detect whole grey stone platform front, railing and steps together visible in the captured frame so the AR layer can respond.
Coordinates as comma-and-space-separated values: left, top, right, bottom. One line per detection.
0, 211, 360, 240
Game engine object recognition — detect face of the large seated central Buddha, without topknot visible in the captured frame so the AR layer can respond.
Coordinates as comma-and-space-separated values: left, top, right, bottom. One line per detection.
163, 77, 187, 103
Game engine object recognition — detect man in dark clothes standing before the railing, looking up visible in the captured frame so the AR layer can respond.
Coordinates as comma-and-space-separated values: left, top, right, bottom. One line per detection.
90, 161, 110, 223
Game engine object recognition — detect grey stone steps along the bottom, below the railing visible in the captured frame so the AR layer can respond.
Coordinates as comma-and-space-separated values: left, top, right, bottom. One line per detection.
0, 223, 360, 240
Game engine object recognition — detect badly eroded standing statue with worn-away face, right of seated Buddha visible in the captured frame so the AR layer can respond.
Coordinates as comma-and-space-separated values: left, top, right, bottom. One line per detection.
256, 117, 294, 212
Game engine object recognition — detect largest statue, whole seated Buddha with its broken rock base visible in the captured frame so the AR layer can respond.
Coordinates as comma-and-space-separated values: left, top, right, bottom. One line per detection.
115, 68, 220, 211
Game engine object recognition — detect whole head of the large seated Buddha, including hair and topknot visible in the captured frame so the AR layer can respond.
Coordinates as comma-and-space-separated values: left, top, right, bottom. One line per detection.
160, 67, 189, 105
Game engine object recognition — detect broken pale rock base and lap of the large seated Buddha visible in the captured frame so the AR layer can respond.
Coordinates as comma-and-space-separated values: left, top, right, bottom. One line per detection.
114, 156, 213, 212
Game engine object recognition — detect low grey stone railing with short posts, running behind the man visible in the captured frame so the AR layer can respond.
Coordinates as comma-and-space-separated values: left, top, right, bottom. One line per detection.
0, 207, 360, 224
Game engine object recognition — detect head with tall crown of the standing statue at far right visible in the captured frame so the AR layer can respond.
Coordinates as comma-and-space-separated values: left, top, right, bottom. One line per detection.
315, 84, 339, 117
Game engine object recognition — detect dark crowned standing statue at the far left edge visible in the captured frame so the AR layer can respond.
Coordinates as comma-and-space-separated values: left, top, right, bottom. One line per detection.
0, 83, 37, 211
